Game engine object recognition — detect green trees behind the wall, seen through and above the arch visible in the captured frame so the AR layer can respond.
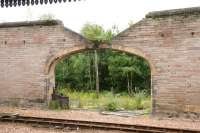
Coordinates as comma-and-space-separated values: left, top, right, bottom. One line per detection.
56, 24, 151, 96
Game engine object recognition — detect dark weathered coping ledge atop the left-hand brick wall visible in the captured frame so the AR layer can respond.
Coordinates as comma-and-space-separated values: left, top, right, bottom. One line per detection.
0, 20, 62, 28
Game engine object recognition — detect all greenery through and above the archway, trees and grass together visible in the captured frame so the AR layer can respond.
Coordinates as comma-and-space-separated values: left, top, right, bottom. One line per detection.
55, 24, 151, 110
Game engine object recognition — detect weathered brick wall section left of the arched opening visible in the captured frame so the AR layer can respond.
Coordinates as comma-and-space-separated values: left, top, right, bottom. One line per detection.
0, 21, 87, 104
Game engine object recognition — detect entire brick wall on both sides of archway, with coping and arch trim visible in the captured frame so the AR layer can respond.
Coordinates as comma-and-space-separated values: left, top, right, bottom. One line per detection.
0, 8, 200, 114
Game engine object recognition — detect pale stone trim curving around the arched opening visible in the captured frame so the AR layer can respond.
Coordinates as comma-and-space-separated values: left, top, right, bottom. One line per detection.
45, 44, 156, 113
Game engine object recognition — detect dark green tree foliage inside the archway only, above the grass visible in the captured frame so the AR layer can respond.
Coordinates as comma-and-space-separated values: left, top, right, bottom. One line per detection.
55, 49, 150, 94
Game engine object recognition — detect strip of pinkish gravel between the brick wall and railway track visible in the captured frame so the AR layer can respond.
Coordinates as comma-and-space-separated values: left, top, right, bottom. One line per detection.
0, 107, 200, 130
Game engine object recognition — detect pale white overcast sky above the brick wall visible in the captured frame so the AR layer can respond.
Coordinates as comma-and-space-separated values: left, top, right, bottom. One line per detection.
0, 0, 200, 32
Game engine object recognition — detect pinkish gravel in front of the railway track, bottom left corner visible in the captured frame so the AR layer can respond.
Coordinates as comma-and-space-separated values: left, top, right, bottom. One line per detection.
0, 122, 125, 133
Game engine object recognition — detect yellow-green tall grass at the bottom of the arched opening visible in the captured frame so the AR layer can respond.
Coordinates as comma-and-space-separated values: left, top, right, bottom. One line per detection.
54, 88, 151, 111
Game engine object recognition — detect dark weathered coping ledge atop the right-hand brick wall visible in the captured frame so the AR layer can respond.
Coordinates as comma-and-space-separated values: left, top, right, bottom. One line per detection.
146, 7, 200, 18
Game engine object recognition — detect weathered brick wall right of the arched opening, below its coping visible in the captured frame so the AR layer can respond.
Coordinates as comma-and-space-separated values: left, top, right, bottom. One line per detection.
112, 9, 200, 114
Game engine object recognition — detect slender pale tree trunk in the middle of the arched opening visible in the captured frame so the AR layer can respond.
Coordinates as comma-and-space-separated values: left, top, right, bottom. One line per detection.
94, 50, 99, 98
